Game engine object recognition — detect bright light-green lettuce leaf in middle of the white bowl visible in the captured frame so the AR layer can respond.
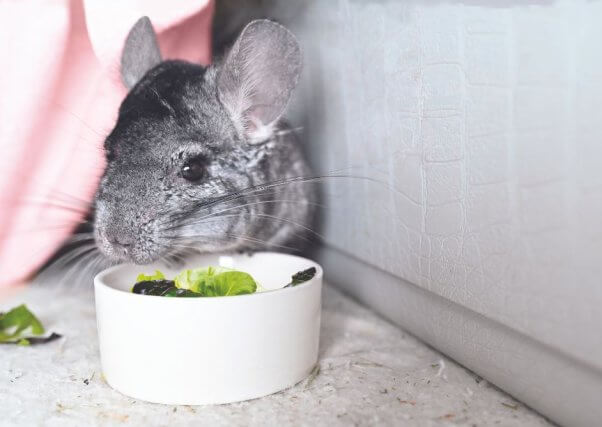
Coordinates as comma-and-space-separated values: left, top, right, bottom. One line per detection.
174, 267, 257, 297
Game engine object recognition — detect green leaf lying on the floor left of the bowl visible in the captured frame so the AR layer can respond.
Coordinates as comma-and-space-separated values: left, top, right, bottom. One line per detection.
0, 304, 61, 345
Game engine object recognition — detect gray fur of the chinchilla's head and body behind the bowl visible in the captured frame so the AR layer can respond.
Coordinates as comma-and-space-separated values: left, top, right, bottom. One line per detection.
94, 20, 316, 264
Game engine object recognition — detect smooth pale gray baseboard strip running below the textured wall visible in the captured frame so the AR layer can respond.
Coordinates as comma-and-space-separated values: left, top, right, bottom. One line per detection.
316, 247, 602, 426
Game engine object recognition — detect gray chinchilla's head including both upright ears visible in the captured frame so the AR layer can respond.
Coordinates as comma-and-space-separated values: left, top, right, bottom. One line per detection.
94, 17, 301, 264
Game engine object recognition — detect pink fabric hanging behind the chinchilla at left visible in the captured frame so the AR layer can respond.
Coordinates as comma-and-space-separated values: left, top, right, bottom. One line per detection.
0, 0, 213, 287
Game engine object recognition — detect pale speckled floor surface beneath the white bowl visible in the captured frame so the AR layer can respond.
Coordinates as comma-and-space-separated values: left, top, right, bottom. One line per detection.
0, 287, 549, 426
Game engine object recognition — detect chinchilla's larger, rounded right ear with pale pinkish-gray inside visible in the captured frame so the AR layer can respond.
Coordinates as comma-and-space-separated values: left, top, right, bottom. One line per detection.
217, 20, 301, 143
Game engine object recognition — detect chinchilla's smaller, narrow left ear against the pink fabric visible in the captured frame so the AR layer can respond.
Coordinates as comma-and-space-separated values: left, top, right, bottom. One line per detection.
121, 16, 161, 89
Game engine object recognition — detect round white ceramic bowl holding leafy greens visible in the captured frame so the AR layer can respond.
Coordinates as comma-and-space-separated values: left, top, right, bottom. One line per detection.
94, 252, 322, 405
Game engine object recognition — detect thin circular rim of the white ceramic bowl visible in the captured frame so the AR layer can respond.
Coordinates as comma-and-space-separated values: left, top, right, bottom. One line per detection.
94, 251, 324, 304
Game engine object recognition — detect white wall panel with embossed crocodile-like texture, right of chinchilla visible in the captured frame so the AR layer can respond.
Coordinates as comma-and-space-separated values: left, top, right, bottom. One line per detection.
281, 0, 602, 368
